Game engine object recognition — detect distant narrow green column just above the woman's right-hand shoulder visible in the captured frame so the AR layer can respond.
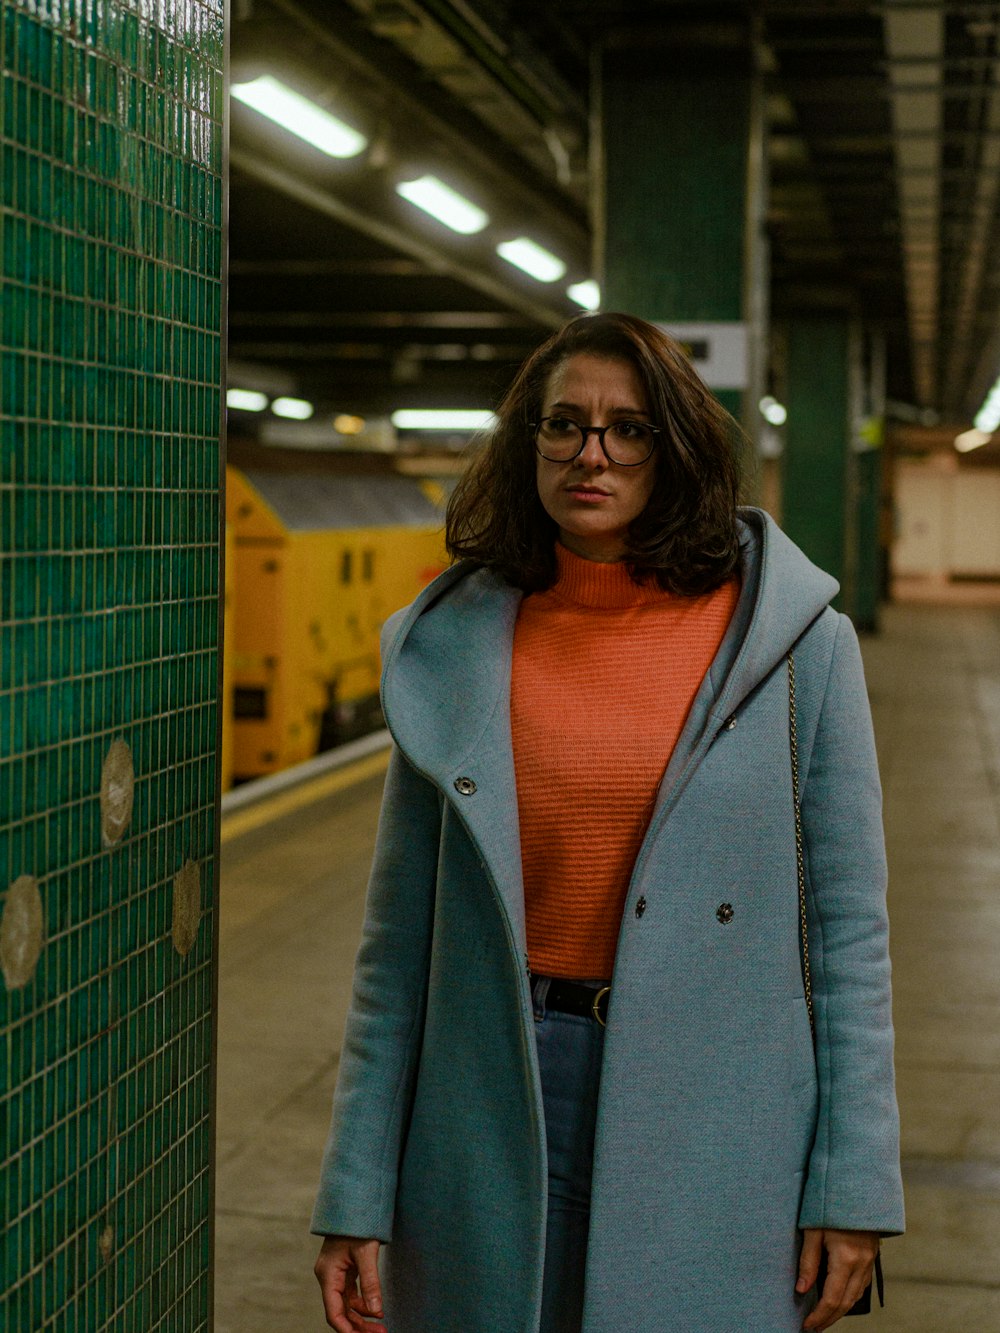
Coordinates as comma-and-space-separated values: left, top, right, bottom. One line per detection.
781, 313, 853, 607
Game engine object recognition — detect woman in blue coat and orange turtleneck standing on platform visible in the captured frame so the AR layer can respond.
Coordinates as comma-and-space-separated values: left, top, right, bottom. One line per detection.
313, 315, 903, 1333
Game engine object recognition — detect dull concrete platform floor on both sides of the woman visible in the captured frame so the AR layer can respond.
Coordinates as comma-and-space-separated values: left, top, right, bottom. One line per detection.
216, 604, 1000, 1333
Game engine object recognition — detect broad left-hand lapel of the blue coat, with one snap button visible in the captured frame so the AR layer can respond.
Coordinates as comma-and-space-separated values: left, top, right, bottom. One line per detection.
383, 565, 525, 956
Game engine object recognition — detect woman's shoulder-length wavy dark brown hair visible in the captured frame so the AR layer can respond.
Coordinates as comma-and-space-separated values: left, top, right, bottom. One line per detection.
447, 313, 743, 596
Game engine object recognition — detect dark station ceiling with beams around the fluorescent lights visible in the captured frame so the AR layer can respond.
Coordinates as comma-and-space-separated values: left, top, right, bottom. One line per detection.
229, 0, 1000, 421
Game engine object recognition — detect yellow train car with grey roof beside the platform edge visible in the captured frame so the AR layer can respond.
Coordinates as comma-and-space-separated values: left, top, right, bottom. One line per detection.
225, 467, 447, 780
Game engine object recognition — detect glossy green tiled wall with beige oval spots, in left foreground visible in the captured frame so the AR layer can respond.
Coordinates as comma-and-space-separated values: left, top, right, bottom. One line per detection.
0, 0, 224, 1333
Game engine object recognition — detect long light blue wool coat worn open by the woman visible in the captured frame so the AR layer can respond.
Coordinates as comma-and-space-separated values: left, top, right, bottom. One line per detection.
313, 509, 903, 1333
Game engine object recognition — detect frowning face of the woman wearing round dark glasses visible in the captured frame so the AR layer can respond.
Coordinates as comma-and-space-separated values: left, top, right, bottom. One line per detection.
536, 352, 655, 563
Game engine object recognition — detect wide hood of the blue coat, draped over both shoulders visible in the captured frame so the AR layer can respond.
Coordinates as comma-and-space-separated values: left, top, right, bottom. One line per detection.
381, 508, 840, 785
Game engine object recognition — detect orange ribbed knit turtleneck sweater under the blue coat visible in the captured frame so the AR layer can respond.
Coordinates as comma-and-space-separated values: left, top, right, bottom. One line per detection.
511, 547, 739, 980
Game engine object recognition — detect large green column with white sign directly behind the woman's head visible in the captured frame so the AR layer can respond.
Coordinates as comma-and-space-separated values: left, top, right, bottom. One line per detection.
595, 28, 767, 436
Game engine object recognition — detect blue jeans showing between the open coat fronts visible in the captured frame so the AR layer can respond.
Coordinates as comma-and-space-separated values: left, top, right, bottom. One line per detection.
532, 977, 604, 1333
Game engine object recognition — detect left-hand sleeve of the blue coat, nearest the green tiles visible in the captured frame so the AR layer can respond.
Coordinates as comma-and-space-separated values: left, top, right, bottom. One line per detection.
311, 749, 441, 1241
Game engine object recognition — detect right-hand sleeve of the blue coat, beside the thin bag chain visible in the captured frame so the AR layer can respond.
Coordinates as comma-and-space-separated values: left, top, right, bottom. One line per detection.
799, 616, 904, 1236
